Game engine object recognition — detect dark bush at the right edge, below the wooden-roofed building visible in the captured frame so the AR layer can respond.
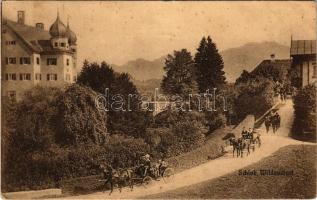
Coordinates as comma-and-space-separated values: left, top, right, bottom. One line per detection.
292, 85, 316, 139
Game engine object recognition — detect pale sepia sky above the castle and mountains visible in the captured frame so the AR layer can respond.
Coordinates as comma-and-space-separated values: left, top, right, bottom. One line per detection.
2, 1, 316, 65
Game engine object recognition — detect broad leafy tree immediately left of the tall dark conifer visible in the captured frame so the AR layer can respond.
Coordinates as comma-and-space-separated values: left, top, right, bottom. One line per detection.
161, 49, 197, 97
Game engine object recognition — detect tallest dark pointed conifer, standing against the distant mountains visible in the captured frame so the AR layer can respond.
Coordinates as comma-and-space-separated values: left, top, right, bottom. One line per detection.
194, 36, 226, 93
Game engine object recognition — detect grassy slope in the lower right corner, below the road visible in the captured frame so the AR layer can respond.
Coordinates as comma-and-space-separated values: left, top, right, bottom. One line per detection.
145, 145, 316, 199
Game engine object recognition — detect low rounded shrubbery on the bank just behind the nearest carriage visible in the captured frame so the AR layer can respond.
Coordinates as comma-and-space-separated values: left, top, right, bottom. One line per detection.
146, 110, 208, 157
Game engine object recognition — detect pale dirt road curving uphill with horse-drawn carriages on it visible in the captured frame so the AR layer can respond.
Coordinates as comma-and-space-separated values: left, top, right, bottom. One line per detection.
70, 100, 312, 199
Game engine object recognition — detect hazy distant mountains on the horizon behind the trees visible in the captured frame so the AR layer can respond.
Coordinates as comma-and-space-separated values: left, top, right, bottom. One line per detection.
112, 42, 289, 82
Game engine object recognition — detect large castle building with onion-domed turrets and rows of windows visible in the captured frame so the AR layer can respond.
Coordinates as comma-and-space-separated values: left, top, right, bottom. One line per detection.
1, 11, 77, 100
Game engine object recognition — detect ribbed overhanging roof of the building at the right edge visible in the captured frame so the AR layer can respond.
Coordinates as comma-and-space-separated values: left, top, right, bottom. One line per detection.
291, 40, 316, 56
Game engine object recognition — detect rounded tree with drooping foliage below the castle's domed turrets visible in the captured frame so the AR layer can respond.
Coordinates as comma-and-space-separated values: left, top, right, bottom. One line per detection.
53, 84, 107, 145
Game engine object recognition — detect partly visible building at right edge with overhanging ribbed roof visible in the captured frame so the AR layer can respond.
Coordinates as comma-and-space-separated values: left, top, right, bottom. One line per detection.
290, 40, 317, 87
